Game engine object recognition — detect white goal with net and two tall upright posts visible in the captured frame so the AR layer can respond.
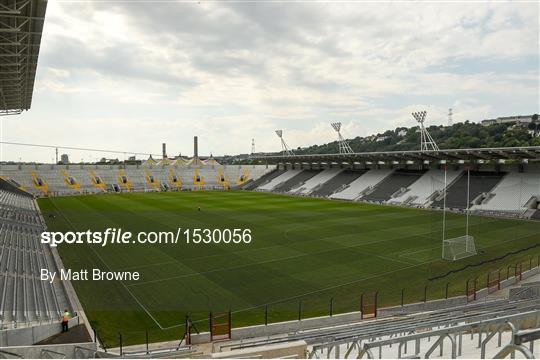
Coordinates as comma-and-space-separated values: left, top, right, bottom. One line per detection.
442, 165, 476, 261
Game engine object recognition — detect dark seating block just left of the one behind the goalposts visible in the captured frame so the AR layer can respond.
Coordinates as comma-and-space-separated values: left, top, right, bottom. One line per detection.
362, 170, 426, 202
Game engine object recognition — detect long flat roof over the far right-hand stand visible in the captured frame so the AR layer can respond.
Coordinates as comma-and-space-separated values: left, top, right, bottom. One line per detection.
251, 146, 540, 163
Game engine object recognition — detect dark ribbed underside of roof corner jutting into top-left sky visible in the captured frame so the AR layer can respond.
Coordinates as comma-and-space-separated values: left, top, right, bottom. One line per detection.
0, 0, 47, 115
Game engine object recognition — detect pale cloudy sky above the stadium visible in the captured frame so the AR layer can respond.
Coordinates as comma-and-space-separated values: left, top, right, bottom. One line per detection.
1, 0, 539, 161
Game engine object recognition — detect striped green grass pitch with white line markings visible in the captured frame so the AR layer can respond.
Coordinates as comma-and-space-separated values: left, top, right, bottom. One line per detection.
39, 191, 540, 346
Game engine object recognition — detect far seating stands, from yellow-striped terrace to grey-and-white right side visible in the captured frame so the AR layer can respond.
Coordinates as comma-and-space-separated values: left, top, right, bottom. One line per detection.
5, 164, 540, 219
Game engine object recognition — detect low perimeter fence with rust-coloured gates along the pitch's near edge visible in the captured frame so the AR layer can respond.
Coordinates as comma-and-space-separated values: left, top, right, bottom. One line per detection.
92, 255, 540, 354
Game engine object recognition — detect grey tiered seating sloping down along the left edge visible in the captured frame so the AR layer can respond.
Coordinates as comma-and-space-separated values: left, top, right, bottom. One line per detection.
0, 188, 70, 329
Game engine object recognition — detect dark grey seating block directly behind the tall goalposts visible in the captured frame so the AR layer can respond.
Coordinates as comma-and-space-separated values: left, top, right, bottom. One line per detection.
432, 171, 506, 209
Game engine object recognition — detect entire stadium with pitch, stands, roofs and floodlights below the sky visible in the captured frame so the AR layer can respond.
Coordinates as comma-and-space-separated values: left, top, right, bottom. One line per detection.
0, 0, 540, 359
